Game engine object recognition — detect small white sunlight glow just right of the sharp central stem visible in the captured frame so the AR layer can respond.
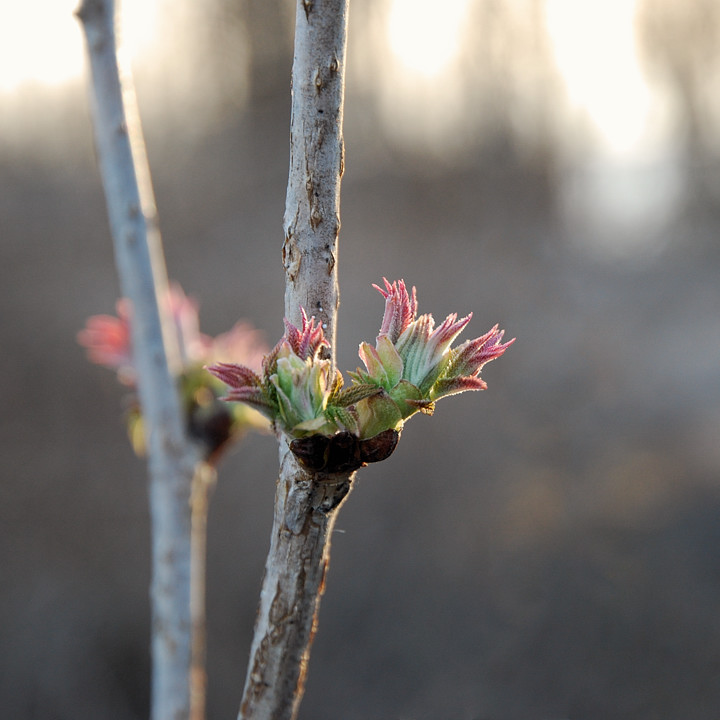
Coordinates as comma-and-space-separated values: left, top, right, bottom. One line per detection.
387, 0, 469, 78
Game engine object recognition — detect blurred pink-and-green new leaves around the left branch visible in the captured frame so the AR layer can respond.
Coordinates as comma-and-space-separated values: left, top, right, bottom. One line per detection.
78, 284, 269, 461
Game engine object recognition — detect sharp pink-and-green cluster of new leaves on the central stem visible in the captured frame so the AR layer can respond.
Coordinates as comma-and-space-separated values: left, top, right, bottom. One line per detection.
208, 280, 513, 452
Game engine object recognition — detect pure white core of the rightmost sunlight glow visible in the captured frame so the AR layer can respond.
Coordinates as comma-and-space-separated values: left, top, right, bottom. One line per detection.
546, 0, 650, 153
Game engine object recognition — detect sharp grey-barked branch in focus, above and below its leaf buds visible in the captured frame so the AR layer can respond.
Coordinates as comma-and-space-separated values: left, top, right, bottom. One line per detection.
239, 0, 354, 720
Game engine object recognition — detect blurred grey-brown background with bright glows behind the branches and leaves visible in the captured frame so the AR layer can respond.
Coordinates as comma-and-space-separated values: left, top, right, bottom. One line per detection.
0, 0, 720, 720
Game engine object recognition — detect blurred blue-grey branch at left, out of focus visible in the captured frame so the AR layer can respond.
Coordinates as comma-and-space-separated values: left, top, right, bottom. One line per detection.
77, 0, 202, 720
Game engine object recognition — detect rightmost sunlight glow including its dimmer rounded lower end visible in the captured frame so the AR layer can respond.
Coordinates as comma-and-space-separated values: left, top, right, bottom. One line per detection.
546, 0, 682, 258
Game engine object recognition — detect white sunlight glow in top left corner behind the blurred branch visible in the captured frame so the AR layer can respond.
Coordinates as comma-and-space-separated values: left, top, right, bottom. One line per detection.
0, 0, 156, 94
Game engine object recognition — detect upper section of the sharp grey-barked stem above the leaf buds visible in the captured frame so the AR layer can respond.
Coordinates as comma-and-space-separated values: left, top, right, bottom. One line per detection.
283, 0, 349, 344
